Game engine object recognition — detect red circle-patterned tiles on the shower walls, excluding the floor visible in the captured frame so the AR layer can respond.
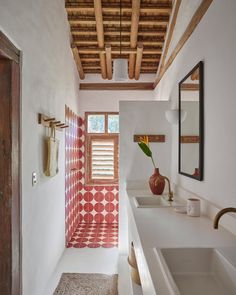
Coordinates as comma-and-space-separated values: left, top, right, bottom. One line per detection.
66, 109, 119, 245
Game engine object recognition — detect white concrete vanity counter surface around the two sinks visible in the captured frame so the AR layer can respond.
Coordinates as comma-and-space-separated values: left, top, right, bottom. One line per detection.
127, 189, 236, 295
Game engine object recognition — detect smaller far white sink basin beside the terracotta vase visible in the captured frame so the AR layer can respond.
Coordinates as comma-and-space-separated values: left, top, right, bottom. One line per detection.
134, 196, 183, 208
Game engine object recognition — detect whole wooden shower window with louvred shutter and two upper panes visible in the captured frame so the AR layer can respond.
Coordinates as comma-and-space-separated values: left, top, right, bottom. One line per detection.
85, 113, 119, 184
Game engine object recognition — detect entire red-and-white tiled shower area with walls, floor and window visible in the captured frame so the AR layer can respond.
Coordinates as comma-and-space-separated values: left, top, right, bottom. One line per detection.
65, 106, 119, 248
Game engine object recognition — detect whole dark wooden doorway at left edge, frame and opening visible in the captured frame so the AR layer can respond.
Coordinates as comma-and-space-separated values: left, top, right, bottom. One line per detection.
0, 31, 21, 295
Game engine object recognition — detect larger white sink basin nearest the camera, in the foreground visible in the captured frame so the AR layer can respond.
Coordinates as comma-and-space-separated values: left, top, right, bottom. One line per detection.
155, 248, 236, 295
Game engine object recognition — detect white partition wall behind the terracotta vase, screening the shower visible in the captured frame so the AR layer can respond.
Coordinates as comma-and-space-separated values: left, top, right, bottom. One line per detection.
119, 101, 171, 253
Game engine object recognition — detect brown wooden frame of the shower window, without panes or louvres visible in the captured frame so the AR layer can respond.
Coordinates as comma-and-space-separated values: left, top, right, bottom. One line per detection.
85, 112, 119, 185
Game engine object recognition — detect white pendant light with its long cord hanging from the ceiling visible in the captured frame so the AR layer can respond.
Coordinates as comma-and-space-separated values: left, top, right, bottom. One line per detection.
113, 0, 128, 82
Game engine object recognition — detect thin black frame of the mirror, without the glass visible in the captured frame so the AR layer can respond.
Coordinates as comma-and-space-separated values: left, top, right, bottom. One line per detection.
179, 61, 204, 181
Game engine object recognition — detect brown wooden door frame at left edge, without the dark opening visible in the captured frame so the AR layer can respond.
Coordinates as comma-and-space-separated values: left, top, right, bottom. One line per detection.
0, 31, 22, 295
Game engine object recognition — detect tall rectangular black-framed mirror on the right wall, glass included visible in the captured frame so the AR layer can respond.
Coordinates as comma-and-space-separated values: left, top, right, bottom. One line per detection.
179, 61, 204, 180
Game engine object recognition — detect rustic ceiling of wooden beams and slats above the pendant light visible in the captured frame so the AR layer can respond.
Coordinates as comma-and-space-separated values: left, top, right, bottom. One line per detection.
65, 0, 172, 79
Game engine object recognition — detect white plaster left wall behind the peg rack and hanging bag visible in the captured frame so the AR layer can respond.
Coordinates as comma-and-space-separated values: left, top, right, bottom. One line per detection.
0, 0, 79, 295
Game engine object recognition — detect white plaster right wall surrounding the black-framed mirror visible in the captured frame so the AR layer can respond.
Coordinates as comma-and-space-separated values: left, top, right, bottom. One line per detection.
155, 0, 236, 207
